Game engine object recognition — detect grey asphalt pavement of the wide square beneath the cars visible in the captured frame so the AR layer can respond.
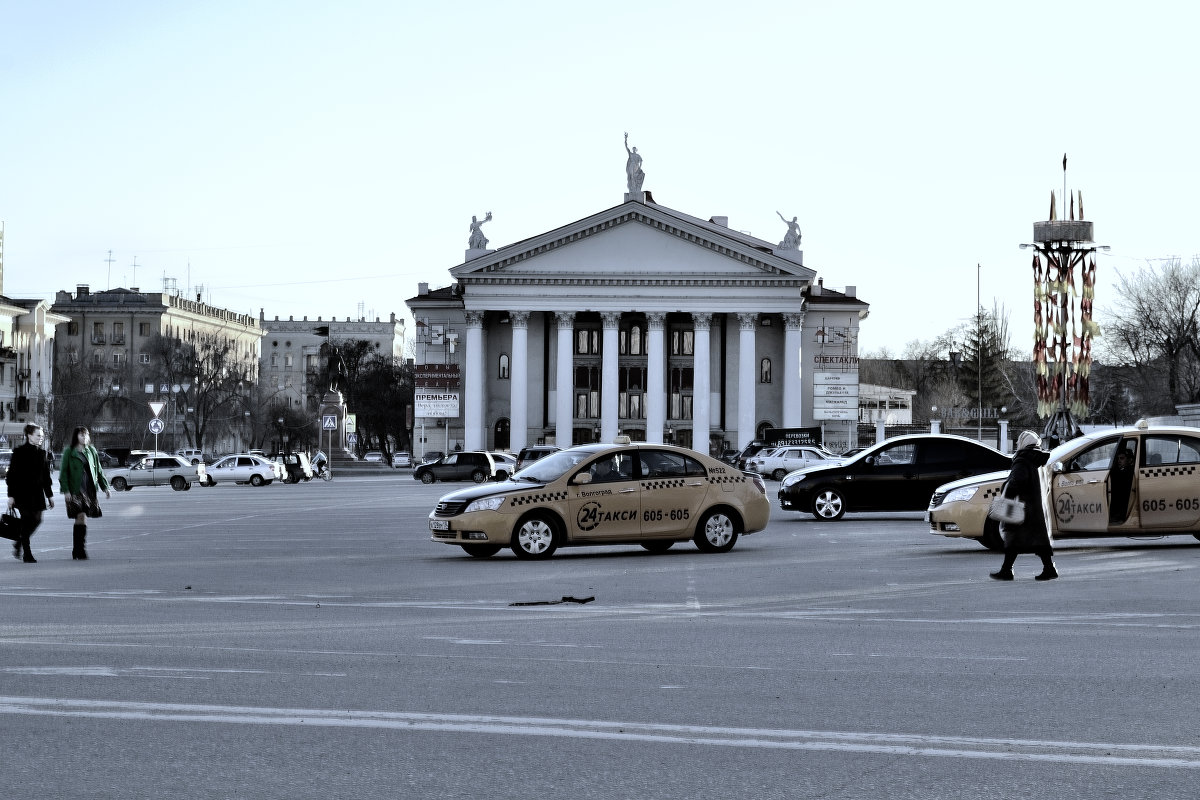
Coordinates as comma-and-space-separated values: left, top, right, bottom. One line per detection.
0, 470, 1200, 800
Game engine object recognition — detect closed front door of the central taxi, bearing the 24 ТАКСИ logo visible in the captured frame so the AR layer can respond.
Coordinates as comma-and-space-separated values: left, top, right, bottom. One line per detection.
566, 455, 642, 540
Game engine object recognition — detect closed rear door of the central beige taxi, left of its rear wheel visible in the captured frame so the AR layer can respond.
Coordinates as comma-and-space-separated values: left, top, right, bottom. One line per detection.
641, 450, 710, 539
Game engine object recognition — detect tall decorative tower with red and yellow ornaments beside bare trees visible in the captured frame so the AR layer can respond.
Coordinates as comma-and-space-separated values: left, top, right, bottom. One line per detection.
1021, 155, 1100, 446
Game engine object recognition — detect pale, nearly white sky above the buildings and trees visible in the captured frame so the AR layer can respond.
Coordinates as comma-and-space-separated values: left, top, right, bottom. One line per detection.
0, 0, 1200, 353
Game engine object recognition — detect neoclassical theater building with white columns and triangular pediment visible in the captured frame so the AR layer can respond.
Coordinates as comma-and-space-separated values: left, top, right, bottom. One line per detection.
407, 182, 868, 453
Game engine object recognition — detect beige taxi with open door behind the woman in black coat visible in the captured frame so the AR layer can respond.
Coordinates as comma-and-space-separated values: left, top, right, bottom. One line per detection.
926, 421, 1200, 551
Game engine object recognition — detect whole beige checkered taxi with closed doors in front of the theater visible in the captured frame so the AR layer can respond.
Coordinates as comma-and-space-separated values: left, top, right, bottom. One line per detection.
430, 440, 770, 559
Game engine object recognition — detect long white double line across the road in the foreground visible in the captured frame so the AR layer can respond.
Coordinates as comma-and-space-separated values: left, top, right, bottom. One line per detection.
0, 696, 1200, 769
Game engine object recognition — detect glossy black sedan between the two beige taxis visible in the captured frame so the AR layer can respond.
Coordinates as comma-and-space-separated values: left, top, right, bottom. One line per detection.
779, 433, 1013, 519
